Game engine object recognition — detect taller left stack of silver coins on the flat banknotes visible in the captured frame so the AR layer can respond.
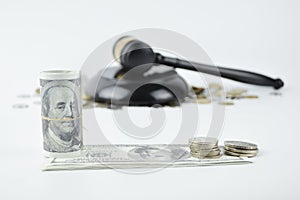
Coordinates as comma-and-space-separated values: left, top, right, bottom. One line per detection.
189, 137, 221, 159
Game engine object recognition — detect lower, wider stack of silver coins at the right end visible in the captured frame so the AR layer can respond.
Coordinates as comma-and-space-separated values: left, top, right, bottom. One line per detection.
224, 141, 258, 158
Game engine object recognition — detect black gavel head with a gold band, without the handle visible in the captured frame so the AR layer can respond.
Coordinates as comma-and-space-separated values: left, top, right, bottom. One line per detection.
113, 36, 156, 72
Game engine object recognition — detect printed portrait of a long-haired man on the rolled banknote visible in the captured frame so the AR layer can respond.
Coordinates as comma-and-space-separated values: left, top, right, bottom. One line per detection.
42, 80, 81, 153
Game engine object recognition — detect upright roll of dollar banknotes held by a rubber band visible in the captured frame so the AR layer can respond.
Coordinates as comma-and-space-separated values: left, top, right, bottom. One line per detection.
40, 70, 83, 157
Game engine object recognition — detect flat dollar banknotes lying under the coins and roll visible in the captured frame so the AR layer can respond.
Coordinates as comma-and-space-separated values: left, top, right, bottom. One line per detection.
44, 144, 251, 171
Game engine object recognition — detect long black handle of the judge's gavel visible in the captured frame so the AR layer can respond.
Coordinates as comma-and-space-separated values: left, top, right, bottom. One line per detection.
155, 53, 284, 89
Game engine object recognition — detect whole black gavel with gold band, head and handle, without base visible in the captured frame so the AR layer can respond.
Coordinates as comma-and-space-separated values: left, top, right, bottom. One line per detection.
113, 36, 284, 89
